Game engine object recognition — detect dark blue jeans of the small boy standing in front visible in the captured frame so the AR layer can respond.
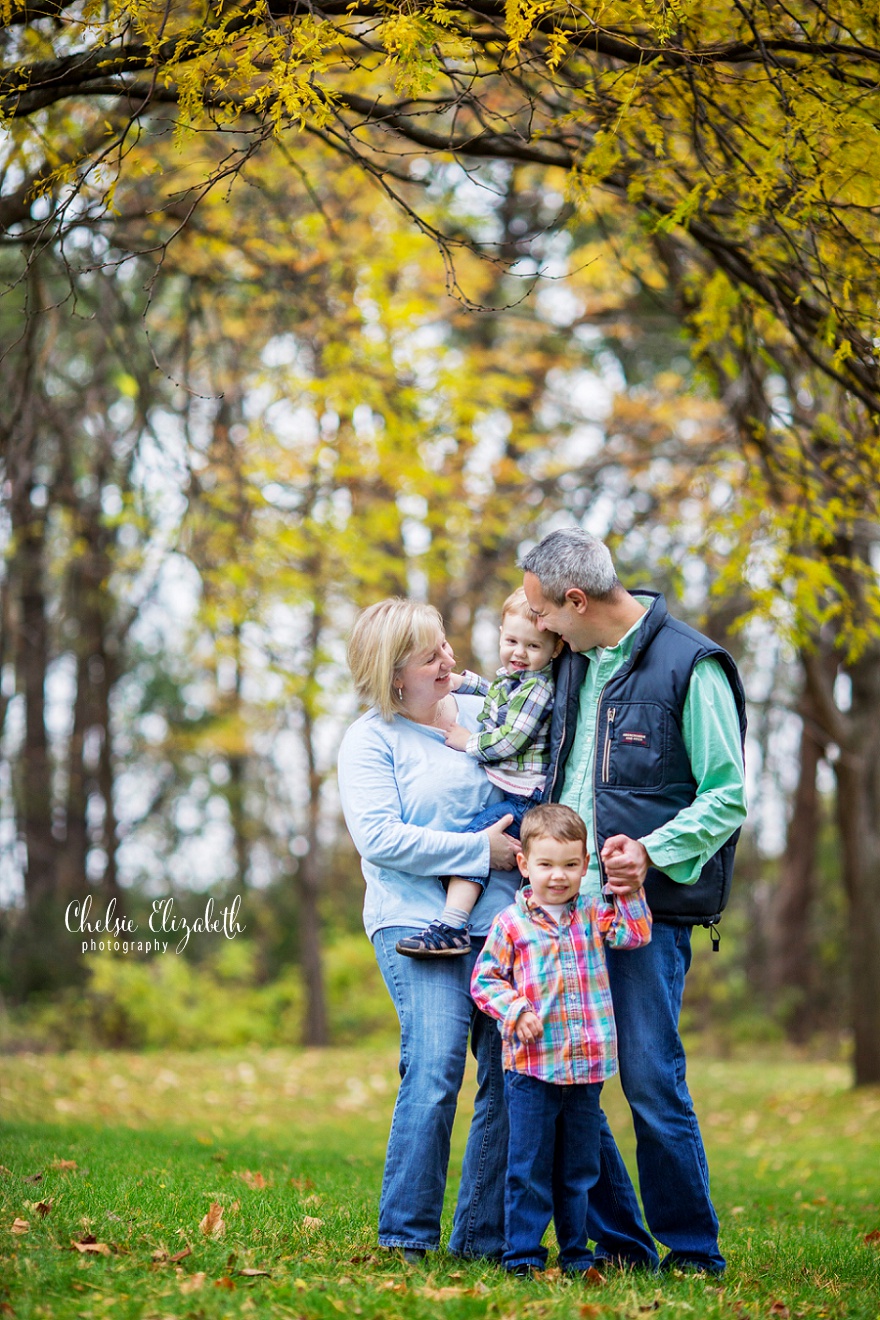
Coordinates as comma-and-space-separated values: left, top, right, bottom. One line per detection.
504, 1072, 602, 1271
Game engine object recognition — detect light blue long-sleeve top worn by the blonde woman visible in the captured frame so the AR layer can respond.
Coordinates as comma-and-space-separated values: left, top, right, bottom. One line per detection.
339, 694, 520, 939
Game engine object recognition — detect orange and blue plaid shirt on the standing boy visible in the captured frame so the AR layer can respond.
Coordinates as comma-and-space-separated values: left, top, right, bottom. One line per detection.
471, 888, 650, 1085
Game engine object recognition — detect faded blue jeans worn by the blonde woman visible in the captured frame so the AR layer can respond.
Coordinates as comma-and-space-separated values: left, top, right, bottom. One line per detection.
373, 927, 508, 1259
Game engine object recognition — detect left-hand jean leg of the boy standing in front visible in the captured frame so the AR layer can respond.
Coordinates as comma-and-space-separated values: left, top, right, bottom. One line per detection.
504, 1072, 562, 1270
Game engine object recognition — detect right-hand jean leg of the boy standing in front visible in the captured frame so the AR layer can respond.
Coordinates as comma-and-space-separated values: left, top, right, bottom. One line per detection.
553, 1082, 602, 1270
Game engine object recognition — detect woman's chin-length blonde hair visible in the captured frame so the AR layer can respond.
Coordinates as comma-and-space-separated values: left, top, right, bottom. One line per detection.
348, 597, 443, 719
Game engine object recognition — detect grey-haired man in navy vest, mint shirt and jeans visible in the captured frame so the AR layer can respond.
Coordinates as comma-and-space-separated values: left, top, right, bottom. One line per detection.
522, 528, 745, 1274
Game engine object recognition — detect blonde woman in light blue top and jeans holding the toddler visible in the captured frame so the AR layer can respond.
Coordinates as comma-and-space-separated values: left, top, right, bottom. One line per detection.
339, 599, 517, 1259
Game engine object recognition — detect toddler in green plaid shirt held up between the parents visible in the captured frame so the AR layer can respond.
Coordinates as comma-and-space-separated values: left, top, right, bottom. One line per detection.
396, 587, 562, 958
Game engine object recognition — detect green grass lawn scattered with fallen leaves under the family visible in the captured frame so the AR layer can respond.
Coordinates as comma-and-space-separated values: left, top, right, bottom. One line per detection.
0, 1047, 880, 1320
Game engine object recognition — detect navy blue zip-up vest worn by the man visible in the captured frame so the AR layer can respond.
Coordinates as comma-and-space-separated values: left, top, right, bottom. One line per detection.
545, 591, 745, 925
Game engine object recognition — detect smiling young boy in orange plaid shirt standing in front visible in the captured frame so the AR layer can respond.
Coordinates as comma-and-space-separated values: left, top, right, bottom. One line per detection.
471, 803, 650, 1275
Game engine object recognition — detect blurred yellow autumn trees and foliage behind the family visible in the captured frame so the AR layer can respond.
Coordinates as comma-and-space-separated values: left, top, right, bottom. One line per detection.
0, 4, 880, 1081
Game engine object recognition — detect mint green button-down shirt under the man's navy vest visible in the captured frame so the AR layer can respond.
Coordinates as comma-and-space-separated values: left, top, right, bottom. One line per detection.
559, 597, 745, 895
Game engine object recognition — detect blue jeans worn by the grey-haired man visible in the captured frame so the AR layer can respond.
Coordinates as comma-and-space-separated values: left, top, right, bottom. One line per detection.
587, 921, 724, 1274
